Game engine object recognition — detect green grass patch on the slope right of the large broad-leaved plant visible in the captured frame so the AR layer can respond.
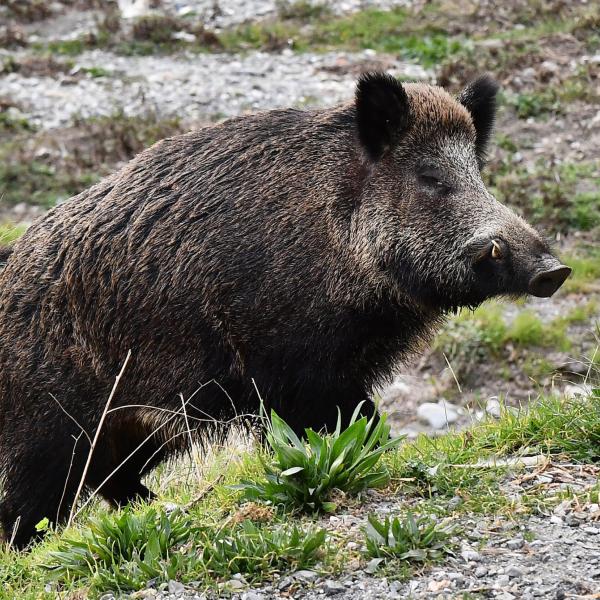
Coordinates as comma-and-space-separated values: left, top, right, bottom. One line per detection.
386, 390, 600, 518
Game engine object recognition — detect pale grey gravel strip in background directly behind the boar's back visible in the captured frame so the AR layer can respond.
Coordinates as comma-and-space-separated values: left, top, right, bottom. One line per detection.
0, 50, 431, 129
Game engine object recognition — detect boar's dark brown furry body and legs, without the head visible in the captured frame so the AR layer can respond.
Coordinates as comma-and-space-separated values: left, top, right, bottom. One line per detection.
0, 109, 431, 534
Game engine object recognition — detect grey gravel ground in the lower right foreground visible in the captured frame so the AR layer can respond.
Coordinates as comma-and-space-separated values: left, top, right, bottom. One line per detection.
95, 457, 600, 600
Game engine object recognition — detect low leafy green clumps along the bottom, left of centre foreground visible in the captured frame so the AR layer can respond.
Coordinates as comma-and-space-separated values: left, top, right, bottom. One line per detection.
44, 507, 326, 593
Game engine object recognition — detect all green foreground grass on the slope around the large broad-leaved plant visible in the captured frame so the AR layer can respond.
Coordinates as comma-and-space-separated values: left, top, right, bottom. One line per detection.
0, 391, 600, 599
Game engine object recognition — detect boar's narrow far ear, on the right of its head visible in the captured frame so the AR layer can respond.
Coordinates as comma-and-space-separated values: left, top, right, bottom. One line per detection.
458, 75, 499, 168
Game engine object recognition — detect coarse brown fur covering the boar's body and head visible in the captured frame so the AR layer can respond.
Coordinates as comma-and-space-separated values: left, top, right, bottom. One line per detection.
0, 75, 568, 546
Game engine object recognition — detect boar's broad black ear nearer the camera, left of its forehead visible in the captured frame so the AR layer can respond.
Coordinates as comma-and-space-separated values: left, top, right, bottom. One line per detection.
355, 73, 410, 160
